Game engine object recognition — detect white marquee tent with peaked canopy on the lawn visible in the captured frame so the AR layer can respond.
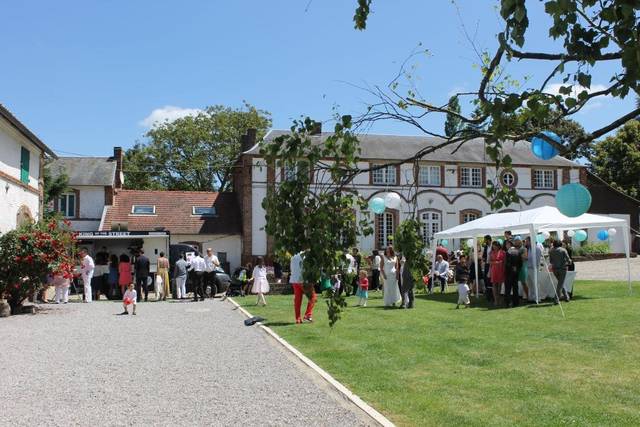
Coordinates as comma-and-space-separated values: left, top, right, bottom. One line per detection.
433, 206, 631, 300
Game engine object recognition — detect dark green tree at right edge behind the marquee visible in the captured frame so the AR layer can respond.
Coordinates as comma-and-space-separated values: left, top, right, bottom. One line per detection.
591, 120, 640, 198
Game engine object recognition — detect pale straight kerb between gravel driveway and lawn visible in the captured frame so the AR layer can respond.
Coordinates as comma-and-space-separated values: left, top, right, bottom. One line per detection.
227, 298, 395, 427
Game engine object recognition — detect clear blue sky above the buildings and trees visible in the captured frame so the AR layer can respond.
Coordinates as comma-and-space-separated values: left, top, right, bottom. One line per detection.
0, 0, 633, 155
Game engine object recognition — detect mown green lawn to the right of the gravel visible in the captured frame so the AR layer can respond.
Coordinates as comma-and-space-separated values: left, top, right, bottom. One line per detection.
235, 282, 640, 426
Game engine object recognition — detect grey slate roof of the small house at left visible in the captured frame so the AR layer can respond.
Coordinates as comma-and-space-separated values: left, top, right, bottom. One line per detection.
49, 157, 116, 186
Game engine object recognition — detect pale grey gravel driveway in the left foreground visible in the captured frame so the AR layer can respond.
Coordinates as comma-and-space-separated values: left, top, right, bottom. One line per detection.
0, 300, 372, 426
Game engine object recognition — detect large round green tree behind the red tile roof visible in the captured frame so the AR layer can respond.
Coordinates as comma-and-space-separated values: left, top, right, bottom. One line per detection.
124, 103, 271, 191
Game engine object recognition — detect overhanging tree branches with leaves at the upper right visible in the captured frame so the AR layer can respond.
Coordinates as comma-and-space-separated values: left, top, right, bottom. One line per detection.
354, 0, 640, 208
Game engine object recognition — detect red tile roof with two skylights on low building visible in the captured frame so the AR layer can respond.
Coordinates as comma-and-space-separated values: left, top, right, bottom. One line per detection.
100, 190, 241, 234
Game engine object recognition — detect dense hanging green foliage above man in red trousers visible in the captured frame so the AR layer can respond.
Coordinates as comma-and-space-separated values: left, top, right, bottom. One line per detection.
261, 116, 372, 324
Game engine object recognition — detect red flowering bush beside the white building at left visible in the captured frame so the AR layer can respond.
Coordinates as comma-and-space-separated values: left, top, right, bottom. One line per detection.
0, 218, 76, 313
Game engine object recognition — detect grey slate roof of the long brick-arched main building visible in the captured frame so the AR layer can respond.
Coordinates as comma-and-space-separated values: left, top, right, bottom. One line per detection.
250, 130, 582, 167
